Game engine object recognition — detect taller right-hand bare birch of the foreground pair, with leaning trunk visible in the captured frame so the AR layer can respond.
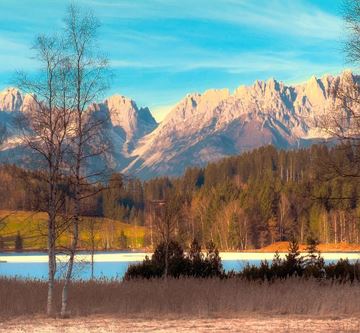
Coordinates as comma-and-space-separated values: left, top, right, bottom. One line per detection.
61, 5, 110, 317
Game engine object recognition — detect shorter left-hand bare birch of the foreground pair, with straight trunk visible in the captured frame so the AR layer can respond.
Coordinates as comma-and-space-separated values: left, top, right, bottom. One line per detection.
16, 35, 72, 316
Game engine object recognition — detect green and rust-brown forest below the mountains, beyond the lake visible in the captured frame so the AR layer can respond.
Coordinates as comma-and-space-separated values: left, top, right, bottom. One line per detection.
0, 145, 360, 250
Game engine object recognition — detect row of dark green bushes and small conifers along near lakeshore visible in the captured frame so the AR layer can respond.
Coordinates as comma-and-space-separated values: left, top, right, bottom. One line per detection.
124, 236, 360, 282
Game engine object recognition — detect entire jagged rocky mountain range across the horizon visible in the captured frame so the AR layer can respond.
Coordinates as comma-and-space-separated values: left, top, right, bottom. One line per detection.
0, 71, 359, 179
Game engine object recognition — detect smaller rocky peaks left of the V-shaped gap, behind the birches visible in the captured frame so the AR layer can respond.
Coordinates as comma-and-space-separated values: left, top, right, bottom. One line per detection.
0, 88, 157, 171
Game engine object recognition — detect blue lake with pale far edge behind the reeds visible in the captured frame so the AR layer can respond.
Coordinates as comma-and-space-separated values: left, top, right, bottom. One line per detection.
0, 251, 360, 280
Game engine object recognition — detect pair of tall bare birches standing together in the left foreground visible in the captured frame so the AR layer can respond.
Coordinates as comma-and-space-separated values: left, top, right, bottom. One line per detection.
16, 1, 110, 317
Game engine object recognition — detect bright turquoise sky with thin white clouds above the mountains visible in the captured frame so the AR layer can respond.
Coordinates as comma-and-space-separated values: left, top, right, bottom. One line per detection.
0, 0, 351, 121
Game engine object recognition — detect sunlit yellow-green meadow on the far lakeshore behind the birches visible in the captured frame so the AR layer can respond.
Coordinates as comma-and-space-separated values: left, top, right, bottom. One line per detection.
0, 210, 146, 250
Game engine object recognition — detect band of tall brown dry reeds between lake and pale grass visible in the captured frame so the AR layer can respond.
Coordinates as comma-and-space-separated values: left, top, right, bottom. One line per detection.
0, 278, 360, 319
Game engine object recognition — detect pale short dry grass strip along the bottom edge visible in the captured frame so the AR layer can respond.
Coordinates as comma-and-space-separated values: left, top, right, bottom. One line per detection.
0, 314, 360, 333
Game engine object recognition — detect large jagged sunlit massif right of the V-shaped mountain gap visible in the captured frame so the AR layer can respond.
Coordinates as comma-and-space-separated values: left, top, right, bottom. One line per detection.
125, 72, 357, 178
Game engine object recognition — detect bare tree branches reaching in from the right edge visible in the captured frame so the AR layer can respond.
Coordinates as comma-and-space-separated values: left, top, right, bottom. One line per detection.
317, 0, 360, 182
